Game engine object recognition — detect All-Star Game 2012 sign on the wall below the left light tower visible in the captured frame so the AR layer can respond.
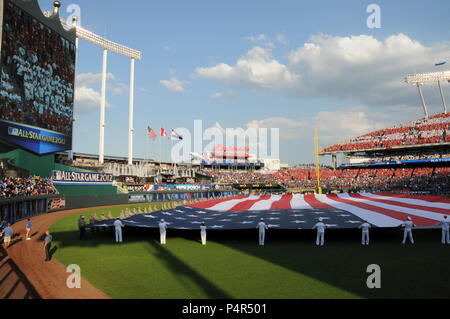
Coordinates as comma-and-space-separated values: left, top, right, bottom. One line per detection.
52, 170, 113, 186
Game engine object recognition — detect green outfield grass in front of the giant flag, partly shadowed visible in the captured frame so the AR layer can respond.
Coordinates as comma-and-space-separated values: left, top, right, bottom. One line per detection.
51, 204, 450, 299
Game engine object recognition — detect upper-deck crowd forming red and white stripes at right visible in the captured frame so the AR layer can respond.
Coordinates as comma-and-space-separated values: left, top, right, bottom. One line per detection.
322, 113, 450, 153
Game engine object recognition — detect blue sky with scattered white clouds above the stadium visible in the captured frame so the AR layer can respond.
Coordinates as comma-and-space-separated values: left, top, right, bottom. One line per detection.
39, 0, 450, 164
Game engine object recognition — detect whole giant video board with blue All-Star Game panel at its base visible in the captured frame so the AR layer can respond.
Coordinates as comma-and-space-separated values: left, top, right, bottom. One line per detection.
0, 0, 76, 154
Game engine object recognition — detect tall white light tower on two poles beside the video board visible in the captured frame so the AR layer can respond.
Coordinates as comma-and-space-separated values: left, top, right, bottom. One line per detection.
61, 10, 142, 165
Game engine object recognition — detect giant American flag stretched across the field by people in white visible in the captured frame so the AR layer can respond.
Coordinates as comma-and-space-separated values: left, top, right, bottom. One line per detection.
91, 193, 450, 230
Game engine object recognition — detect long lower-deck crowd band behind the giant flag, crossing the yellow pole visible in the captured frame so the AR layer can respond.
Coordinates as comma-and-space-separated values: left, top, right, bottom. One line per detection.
203, 167, 450, 193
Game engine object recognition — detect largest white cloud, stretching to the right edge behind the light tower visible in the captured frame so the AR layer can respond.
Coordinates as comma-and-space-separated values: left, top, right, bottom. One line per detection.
196, 33, 450, 106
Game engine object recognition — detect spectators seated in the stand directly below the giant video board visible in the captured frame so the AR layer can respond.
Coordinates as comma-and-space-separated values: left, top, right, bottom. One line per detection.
0, 176, 56, 198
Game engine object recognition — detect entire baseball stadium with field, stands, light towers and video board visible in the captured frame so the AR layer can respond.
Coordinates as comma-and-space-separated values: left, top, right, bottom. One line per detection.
0, 0, 450, 300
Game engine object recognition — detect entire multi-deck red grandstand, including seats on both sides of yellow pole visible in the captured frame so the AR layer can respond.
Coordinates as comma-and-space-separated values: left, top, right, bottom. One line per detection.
198, 113, 450, 194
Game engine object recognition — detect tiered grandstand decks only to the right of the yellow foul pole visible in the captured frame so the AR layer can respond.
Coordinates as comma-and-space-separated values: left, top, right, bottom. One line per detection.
312, 113, 450, 193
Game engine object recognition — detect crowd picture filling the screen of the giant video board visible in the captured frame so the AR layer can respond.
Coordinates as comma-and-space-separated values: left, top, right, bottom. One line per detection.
0, 2, 75, 135
